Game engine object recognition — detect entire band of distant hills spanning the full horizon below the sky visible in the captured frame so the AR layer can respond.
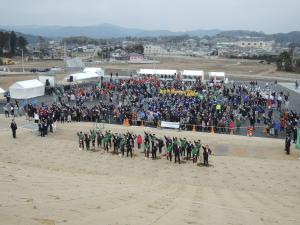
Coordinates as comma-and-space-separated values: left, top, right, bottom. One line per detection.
0, 23, 300, 43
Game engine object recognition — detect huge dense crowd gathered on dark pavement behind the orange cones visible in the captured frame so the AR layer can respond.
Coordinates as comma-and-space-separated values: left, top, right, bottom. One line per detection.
12, 76, 299, 138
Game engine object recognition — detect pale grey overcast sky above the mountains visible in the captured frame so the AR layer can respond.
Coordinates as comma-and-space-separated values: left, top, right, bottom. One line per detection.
0, 0, 300, 33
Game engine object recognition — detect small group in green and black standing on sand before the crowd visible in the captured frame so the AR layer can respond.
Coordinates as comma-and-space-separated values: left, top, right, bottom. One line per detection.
77, 130, 212, 166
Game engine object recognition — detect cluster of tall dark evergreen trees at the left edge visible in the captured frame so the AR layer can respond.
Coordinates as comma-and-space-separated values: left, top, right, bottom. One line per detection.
0, 31, 28, 57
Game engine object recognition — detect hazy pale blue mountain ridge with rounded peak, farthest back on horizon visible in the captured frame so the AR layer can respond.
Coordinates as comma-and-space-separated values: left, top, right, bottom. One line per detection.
0, 23, 220, 38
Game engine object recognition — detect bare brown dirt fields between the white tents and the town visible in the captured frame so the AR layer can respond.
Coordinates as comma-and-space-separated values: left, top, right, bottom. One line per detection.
0, 57, 300, 89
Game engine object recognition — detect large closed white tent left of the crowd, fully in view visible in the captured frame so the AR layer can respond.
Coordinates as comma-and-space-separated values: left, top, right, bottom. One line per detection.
9, 79, 45, 99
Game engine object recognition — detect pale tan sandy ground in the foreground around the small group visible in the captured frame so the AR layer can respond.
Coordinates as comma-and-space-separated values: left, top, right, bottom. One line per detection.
0, 115, 300, 225
